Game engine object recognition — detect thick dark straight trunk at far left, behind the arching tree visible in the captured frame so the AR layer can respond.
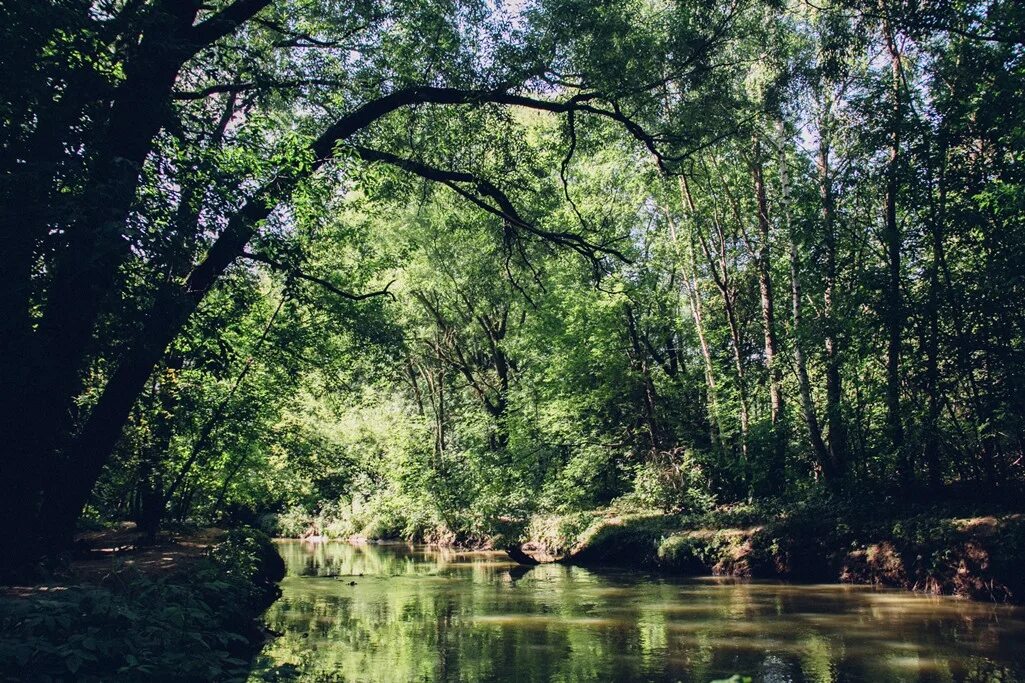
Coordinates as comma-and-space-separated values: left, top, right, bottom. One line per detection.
28, 3, 198, 463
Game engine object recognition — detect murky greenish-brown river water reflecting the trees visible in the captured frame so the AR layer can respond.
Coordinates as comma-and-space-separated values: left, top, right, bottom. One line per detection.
250, 541, 1025, 683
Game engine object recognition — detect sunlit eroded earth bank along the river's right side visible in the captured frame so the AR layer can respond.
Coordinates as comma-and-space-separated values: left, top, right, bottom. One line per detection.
518, 503, 1025, 603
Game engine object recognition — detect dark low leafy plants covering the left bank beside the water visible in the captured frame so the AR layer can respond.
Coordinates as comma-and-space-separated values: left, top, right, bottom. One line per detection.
0, 529, 283, 681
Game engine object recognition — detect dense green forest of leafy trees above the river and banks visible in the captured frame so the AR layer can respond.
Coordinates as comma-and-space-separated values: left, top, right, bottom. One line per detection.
0, 0, 1025, 568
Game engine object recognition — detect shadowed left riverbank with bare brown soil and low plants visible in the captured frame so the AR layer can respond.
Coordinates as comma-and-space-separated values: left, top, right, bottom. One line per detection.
0, 528, 284, 681
